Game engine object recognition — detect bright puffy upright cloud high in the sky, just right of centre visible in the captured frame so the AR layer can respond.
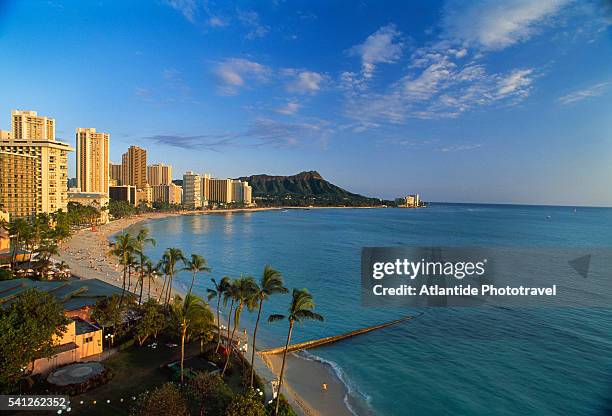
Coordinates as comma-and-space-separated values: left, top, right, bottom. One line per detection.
349, 24, 403, 78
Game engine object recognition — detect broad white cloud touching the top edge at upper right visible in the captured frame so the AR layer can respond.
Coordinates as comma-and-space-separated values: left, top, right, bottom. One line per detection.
442, 0, 571, 50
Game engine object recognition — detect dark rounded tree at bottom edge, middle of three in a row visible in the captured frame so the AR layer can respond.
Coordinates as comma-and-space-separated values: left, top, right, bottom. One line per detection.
187, 372, 233, 416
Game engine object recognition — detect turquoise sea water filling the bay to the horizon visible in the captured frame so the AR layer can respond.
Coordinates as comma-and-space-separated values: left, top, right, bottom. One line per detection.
124, 204, 612, 415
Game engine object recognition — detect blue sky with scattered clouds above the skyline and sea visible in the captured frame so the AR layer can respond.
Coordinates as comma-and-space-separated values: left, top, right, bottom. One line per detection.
0, 0, 612, 206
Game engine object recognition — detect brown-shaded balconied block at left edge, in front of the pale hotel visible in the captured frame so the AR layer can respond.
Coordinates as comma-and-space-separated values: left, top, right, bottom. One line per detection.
0, 151, 36, 219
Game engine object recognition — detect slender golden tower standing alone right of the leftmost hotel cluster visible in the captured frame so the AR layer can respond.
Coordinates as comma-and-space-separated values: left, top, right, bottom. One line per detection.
76, 128, 110, 194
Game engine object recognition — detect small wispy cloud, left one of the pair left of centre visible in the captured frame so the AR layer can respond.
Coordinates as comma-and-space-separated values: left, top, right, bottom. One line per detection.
214, 58, 271, 95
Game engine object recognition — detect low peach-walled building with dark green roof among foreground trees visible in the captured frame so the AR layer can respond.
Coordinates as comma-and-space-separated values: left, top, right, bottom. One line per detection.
0, 279, 121, 374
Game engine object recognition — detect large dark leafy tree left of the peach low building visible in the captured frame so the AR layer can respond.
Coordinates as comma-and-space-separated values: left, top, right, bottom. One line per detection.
0, 289, 68, 390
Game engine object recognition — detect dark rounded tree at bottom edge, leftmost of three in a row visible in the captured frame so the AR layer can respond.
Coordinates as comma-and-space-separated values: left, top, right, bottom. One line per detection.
131, 383, 189, 416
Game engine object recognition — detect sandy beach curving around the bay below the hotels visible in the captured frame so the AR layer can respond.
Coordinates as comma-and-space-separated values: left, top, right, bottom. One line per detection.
55, 207, 364, 416
